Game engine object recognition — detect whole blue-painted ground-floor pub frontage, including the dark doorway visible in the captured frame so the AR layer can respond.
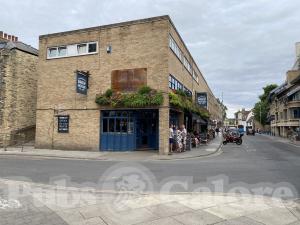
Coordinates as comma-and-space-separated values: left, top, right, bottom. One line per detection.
100, 110, 158, 151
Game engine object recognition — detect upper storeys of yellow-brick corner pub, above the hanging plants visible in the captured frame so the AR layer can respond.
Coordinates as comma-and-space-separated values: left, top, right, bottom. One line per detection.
37, 16, 221, 118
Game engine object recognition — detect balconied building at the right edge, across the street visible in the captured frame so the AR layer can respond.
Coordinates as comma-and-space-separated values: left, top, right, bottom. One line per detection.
269, 43, 300, 137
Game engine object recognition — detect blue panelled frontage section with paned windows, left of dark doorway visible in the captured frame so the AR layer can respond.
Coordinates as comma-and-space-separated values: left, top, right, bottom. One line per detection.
100, 110, 136, 151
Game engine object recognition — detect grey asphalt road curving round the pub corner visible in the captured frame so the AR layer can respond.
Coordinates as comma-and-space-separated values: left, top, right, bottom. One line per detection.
0, 135, 300, 197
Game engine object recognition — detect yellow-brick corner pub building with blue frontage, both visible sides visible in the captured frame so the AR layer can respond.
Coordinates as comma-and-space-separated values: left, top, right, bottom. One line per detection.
36, 16, 218, 154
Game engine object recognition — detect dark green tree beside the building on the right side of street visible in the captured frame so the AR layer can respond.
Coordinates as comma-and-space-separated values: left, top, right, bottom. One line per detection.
253, 84, 277, 125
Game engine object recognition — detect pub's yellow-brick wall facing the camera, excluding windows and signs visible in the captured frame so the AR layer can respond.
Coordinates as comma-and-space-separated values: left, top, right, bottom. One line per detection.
36, 19, 169, 151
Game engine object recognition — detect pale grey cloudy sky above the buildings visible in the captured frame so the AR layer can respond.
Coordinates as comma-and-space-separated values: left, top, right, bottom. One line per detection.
0, 0, 300, 116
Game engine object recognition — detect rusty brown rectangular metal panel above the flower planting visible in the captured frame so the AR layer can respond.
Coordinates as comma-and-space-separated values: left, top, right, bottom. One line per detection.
111, 68, 147, 92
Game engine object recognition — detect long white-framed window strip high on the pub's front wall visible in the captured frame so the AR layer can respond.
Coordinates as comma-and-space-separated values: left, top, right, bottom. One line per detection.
47, 42, 98, 59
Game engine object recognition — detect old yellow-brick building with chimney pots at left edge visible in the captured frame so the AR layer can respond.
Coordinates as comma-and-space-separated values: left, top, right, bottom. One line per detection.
0, 32, 38, 145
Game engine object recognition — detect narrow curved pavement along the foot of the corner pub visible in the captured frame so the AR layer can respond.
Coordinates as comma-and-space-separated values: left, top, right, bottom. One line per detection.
0, 136, 222, 161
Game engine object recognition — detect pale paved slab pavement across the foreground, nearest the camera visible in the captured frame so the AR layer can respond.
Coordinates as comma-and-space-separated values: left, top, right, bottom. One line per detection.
0, 179, 300, 225
